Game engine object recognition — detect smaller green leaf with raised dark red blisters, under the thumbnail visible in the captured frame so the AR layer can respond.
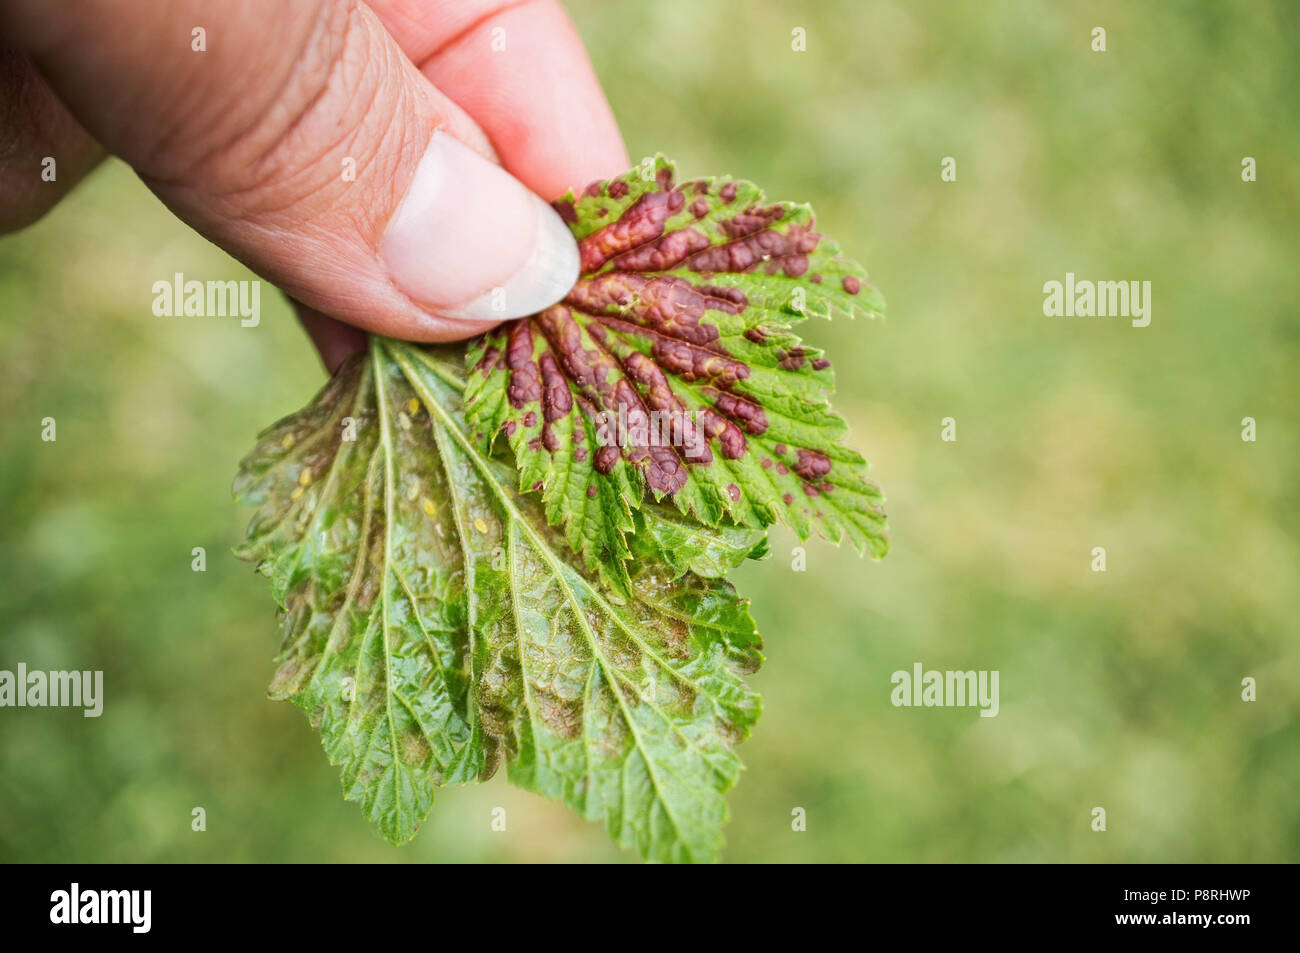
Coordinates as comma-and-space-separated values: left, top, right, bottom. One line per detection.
465, 157, 888, 577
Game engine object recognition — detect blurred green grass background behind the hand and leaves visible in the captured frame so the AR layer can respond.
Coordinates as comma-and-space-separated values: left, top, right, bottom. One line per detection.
0, 0, 1300, 862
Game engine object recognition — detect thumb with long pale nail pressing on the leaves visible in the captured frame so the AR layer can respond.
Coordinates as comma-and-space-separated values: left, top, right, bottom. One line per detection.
0, 0, 579, 341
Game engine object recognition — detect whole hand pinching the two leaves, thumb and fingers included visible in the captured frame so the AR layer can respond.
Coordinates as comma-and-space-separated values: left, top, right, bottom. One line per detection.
0, 0, 629, 371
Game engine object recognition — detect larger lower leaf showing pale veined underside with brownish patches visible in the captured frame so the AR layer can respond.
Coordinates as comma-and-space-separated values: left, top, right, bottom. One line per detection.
235, 338, 766, 861
